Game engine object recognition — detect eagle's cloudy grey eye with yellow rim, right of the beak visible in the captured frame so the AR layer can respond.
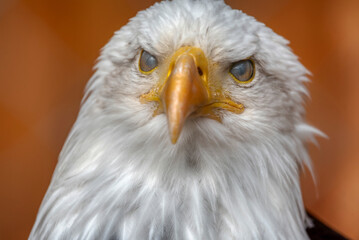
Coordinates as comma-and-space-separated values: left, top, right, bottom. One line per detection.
229, 59, 254, 83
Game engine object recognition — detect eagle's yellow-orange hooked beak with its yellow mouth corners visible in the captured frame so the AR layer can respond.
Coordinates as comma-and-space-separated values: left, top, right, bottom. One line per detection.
141, 47, 244, 144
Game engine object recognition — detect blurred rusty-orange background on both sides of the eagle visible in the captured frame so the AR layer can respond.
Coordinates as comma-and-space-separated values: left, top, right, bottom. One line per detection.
0, 0, 359, 240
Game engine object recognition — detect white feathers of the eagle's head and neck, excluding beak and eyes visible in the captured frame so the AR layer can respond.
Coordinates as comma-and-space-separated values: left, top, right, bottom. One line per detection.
29, 0, 319, 240
